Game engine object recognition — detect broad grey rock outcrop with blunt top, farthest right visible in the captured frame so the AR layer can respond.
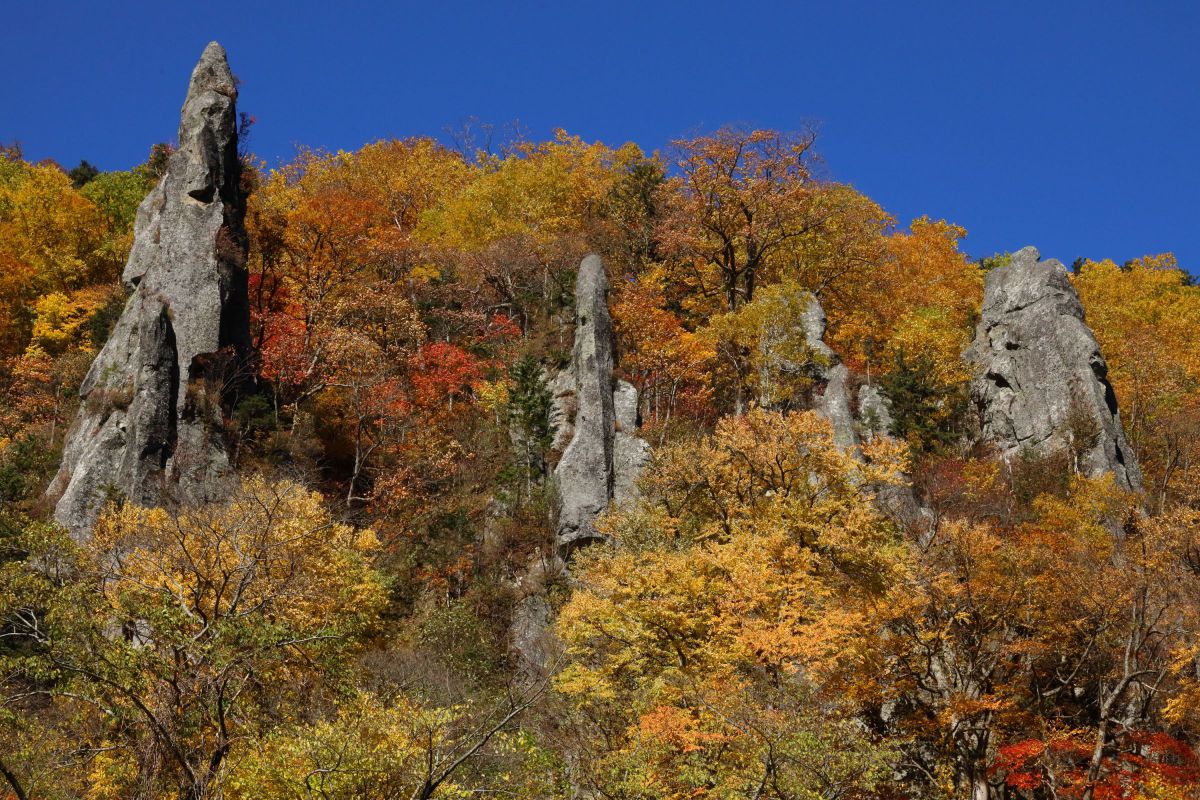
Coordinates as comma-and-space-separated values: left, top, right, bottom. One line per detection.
967, 247, 1141, 489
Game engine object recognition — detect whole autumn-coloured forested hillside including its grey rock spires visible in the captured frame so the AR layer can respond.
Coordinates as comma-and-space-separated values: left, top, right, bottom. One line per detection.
0, 44, 1200, 800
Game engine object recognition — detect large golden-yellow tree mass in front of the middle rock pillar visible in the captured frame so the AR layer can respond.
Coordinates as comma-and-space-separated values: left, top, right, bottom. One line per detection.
558, 409, 901, 798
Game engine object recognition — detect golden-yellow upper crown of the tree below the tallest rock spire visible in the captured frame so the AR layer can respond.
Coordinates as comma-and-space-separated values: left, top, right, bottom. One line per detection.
90, 477, 384, 636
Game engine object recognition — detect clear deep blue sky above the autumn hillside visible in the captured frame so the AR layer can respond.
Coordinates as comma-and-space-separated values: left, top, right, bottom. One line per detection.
0, 0, 1200, 272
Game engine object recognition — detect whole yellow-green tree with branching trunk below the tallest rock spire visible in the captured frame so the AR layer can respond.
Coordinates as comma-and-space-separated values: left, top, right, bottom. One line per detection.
32, 477, 385, 798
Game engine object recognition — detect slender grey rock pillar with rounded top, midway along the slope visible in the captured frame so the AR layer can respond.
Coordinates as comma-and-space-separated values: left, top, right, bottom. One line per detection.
551, 254, 649, 554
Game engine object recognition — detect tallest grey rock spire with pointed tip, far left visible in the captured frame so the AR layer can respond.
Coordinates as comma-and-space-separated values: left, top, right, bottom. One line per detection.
49, 42, 250, 537
